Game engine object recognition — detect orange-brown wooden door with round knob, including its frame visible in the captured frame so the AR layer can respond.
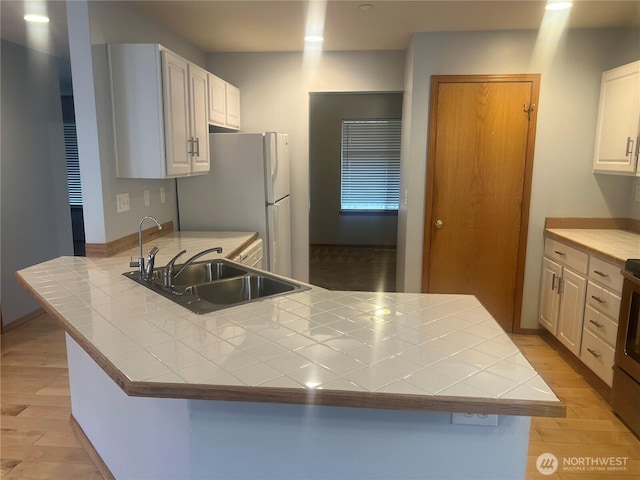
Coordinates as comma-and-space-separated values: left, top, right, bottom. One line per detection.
423, 75, 539, 331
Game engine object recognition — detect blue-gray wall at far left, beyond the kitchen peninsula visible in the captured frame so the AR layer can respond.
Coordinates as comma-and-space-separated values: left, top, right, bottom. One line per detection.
0, 41, 73, 325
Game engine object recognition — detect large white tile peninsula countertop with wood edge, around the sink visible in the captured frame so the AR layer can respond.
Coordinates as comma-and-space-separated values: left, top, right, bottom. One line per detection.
16, 232, 566, 416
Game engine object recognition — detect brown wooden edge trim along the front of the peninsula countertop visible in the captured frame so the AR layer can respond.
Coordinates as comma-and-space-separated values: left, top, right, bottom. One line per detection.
16, 272, 567, 417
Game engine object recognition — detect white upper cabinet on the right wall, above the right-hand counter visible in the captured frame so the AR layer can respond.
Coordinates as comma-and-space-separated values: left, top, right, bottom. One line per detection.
593, 61, 640, 176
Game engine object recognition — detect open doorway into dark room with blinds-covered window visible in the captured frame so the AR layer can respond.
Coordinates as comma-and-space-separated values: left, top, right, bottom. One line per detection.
309, 92, 402, 291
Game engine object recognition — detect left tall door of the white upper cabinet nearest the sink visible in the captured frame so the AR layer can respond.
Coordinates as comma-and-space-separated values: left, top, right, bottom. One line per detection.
162, 50, 191, 176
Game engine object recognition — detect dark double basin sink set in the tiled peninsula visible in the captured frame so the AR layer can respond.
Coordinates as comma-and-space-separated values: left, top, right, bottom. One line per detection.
123, 259, 310, 313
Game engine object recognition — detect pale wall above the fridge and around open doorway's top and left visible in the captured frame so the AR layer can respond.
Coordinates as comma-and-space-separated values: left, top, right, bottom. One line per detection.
207, 51, 405, 281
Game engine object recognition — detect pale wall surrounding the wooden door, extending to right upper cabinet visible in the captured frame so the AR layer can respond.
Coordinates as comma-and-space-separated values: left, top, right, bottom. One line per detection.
398, 29, 640, 328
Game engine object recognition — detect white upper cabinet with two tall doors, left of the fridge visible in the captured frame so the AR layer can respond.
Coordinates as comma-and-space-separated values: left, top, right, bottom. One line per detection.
108, 44, 210, 178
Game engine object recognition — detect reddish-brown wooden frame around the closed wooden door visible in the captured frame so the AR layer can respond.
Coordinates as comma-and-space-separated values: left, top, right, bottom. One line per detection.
422, 73, 540, 333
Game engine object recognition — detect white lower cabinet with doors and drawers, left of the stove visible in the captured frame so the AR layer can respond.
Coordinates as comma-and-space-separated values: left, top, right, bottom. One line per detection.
539, 238, 622, 386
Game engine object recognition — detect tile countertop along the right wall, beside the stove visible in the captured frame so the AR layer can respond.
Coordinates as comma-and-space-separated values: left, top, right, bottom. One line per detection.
545, 228, 640, 267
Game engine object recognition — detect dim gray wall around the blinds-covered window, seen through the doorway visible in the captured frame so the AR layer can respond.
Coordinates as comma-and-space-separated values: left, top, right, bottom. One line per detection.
309, 93, 402, 245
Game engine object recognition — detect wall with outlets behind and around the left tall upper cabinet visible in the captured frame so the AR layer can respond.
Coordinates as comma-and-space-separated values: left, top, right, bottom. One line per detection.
67, 1, 205, 243
